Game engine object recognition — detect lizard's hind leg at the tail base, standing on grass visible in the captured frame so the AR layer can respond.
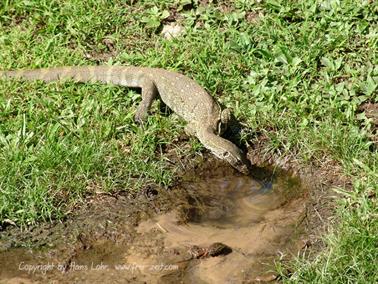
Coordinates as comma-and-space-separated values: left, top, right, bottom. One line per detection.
135, 80, 158, 124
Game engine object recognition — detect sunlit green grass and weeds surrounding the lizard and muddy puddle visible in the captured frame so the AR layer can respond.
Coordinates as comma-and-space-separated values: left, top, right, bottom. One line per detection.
0, 0, 378, 283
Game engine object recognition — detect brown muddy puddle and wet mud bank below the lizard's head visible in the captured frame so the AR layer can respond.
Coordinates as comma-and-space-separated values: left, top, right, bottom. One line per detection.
0, 159, 311, 283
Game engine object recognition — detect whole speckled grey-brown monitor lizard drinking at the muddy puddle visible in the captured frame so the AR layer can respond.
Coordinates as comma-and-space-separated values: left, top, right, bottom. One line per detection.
0, 66, 249, 174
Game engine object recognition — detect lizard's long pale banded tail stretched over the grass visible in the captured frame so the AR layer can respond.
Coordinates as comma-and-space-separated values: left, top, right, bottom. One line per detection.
0, 66, 138, 87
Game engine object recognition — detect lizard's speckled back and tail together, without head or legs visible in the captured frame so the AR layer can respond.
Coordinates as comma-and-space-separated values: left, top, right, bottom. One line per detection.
0, 66, 220, 123
